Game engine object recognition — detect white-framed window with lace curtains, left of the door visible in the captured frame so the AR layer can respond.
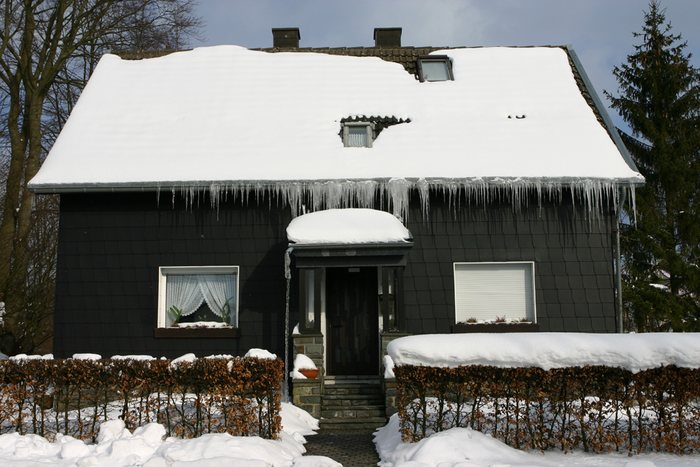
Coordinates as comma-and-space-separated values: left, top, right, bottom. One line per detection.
158, 266, 238, 328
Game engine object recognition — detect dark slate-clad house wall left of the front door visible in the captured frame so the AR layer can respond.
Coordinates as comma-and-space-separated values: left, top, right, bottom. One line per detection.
54, 193, 290, 357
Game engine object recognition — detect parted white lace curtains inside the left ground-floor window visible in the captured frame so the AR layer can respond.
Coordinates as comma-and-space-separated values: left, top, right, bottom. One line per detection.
165, 274, 237, 326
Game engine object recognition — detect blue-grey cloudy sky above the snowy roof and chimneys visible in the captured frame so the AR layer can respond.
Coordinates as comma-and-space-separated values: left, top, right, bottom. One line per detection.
193, 0, 700, 128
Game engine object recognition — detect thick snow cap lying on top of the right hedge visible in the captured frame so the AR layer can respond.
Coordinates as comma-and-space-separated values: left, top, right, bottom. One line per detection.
387, 332, 700, 372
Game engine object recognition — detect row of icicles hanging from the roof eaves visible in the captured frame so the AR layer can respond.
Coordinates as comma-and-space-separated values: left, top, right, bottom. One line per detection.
164, 178, 636, 221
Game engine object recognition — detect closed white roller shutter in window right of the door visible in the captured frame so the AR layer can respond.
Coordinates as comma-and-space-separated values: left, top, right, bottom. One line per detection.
454, 262, 535, 323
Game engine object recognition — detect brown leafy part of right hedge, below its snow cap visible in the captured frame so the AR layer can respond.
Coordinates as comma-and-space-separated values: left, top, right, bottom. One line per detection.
394, 366, 700, 453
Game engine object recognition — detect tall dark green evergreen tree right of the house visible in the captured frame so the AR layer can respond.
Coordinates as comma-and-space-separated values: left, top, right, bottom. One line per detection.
606, 0, 700, 331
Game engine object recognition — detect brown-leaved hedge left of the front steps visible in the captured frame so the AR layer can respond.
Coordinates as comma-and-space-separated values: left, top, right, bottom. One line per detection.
0, 358, 284, 440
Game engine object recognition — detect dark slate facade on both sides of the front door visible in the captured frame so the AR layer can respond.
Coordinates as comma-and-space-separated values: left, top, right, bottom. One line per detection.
54, 192, 615, 357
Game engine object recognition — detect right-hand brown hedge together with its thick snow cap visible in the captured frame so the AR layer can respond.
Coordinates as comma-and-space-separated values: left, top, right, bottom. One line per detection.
388, 333, 700, 453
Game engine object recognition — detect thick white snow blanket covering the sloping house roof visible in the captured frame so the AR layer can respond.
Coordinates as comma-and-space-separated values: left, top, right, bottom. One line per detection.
31, 46, 642, 191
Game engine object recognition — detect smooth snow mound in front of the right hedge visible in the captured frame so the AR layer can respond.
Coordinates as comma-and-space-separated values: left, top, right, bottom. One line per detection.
374, 415, 700, 467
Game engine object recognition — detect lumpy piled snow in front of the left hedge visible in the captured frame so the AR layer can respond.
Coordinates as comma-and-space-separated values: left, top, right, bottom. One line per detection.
0, 404, 340, 467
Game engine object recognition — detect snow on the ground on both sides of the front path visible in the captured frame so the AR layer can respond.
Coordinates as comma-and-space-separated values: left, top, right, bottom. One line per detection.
0, 403, 700, 467
